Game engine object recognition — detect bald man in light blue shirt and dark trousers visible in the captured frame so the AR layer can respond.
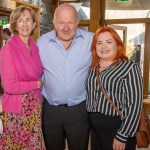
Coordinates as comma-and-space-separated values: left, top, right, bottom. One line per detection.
37, 4, 93, 150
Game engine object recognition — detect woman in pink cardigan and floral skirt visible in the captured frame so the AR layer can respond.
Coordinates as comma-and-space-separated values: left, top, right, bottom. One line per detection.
0, 6, 44, 150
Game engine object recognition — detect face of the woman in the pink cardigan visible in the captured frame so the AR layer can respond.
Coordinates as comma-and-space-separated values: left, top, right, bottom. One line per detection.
16, 10, 35, 38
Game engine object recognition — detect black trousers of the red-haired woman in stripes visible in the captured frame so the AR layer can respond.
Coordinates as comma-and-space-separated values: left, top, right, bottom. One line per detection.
89, 113, 136, 150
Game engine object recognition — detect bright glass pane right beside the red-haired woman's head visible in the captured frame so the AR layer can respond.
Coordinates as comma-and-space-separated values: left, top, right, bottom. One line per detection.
110, 24, 145, 71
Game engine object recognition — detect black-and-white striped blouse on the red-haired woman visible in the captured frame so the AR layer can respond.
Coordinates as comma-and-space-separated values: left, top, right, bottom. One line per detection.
86, 60, 143, 142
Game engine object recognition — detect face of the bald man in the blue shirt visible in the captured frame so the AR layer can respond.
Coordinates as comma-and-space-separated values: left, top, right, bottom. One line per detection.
53, 9, 79, 41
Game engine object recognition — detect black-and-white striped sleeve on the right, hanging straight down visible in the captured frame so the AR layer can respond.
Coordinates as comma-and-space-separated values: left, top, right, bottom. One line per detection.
115, 64, 143, 143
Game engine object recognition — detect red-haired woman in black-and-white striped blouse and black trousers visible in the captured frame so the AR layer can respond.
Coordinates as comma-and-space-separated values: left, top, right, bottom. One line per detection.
86, 27, 143, 150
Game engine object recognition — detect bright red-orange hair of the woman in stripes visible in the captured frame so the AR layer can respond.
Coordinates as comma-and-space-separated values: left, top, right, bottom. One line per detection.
91, 27, 128, 68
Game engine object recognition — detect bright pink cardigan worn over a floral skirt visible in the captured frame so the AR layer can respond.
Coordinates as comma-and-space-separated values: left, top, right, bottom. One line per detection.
0, 35, 43, 113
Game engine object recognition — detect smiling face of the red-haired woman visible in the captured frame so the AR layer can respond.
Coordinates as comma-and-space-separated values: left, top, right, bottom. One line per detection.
96, 31, 118, 60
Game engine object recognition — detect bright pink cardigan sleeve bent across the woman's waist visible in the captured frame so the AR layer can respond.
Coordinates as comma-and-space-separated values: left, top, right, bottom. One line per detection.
0, 45, 38, 94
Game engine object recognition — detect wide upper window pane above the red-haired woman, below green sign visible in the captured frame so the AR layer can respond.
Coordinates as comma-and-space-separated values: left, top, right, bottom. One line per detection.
105, 0, 150, 19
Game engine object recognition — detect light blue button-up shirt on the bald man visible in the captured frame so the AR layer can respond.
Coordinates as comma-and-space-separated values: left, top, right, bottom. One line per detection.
37, 29, 93, 106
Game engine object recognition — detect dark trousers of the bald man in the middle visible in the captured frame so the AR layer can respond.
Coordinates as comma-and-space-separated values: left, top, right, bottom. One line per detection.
42, 99, 89, 150
